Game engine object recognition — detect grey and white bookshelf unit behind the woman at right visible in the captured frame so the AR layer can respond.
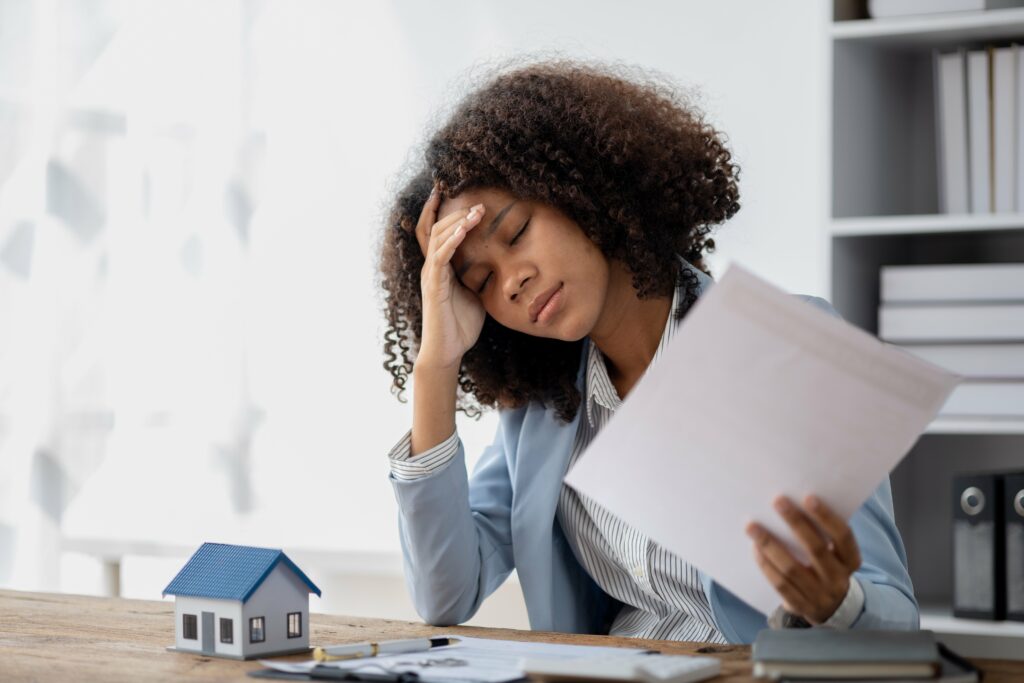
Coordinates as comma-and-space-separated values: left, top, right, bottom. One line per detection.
826, 0, 1024, 659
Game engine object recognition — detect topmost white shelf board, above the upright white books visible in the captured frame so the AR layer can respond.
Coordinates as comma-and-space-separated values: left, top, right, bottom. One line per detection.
831, 8, 1024, 47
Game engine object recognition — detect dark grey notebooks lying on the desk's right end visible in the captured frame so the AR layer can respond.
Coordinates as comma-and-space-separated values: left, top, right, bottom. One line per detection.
751, 629, 942, 680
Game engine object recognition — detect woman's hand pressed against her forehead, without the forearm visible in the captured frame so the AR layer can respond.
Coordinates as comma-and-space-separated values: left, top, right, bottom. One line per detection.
416, 182, 486, 369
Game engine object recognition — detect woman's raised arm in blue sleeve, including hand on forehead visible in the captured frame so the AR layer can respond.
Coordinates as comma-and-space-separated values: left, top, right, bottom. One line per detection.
389, 182, 512, 626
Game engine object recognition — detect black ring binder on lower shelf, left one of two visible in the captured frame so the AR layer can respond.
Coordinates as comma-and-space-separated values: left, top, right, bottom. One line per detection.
951, 473, 1006, 620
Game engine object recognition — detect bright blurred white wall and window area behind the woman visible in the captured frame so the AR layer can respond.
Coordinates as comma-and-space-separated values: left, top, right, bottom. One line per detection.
0, 0, 833, 628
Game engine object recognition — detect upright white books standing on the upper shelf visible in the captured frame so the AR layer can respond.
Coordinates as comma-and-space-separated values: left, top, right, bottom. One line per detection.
933, 44, 1024, 214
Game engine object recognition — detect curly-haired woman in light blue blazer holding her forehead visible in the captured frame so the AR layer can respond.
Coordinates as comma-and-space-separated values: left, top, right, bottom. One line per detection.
381, 57, 919, 642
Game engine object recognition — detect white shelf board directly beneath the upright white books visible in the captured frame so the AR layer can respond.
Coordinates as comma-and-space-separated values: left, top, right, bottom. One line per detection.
830, 213, 1024, 237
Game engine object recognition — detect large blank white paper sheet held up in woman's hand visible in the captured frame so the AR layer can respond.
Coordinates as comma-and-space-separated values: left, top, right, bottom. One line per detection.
565, 266, 961, 614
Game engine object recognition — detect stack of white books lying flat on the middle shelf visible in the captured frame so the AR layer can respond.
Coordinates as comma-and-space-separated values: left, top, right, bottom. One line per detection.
879, 263, 1024, 420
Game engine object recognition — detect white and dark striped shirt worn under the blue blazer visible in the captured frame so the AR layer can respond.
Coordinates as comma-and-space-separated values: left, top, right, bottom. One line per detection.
388, 276, 863, 643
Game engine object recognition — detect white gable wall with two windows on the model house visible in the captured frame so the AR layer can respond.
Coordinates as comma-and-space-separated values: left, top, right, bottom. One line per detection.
234, 562, 309, 656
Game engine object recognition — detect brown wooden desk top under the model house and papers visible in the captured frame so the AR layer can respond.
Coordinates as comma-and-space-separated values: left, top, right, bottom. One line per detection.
0, 591, 1024, 683
